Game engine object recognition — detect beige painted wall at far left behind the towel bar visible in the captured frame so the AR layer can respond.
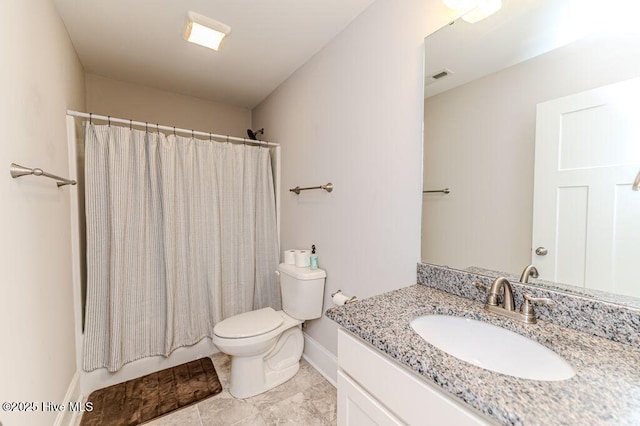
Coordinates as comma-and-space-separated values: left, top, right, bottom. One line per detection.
0, 0, 84, 426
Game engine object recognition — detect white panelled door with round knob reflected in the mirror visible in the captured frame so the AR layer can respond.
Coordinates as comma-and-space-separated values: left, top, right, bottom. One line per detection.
532, 79, 640, 296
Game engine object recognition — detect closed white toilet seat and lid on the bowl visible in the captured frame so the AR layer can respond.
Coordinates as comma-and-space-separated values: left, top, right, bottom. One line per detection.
213, 308, 284, 339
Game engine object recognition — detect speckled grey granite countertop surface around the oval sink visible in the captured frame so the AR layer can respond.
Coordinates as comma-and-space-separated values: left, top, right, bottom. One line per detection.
326, 284, 640, 425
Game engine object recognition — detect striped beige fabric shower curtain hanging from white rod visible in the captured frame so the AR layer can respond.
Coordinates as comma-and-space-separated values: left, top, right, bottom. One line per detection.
83, 124, 280, 371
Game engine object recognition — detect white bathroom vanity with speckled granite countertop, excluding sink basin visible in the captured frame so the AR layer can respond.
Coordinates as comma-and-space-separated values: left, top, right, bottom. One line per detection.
326, 264, 640, 426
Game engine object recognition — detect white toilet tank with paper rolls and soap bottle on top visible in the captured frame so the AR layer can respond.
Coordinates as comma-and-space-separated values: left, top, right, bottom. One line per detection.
278, 263, 327, 320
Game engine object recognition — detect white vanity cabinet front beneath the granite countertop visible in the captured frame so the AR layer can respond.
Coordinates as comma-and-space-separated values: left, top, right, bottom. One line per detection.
338, 328, 496, 426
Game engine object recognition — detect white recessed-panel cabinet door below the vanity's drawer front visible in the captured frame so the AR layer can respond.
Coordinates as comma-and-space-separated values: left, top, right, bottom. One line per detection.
338, 371, 403, 426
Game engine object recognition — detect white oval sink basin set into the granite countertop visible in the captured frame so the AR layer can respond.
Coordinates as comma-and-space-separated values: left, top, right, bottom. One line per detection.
411, 315, 576, 381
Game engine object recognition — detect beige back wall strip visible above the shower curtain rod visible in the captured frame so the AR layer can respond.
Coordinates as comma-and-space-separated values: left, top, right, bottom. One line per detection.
86, 74, 251, 137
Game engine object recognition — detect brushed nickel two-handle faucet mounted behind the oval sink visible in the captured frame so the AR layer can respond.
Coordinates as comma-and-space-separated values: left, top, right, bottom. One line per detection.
476, 276, 555, 324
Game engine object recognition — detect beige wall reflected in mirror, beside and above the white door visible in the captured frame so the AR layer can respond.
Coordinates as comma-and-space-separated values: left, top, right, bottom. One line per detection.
422, 35, 640, 274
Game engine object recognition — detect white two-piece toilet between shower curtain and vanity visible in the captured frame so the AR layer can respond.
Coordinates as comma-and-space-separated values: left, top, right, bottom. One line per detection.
213, 263, 327, 398
